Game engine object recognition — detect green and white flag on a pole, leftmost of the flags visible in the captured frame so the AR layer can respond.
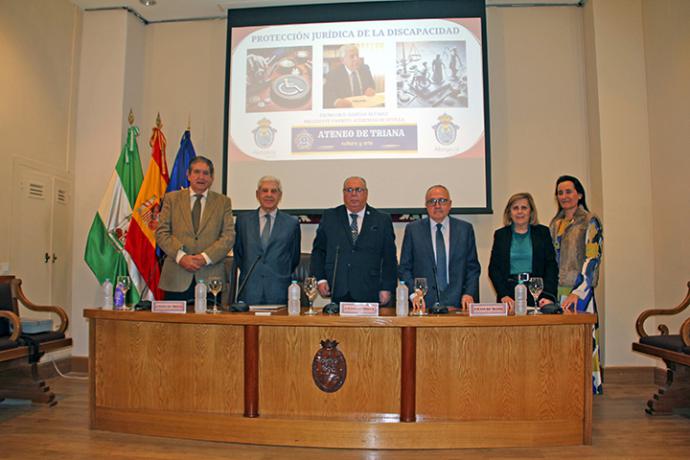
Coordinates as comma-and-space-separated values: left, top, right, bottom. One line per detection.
84, 126, 146, 304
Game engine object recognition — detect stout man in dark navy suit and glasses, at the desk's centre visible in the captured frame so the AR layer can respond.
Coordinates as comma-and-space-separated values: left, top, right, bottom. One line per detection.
311, 177, 397, 305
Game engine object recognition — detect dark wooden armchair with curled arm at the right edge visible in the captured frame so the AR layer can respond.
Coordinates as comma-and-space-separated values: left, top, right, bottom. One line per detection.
632, 281, 690, 415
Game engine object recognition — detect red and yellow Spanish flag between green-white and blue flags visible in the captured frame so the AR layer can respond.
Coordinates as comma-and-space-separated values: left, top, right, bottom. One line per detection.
125, 120, 170, 299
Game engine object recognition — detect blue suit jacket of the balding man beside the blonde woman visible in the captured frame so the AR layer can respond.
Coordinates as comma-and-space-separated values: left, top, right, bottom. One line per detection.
399, 217, 481, 307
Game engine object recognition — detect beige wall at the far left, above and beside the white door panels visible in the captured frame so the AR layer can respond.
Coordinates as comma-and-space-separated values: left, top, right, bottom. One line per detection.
0, 0, 81, 272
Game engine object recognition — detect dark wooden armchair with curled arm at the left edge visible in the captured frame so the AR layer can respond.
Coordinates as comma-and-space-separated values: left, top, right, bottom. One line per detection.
0, 276, 72, 406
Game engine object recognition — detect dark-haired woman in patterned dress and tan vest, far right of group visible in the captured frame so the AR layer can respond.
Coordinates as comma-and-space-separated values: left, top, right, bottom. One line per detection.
549, 176, 603, 394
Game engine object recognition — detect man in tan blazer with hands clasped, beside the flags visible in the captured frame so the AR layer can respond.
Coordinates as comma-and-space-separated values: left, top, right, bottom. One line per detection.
156, 156, 235, 300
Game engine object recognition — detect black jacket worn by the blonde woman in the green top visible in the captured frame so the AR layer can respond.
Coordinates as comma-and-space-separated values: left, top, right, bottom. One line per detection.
489, 225, 558, 302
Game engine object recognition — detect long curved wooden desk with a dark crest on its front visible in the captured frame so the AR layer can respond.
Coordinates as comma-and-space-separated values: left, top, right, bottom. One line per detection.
84, 309, 595, 449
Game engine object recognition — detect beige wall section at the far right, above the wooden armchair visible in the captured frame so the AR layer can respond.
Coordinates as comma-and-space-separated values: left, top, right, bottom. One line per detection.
636, 0, 690, 332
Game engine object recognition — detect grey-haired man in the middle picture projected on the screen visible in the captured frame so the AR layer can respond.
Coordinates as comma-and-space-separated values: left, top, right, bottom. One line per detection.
323, 45, 376, 108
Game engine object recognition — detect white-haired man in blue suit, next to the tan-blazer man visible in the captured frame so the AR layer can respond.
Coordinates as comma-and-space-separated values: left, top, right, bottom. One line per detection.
234, 176, 302, 304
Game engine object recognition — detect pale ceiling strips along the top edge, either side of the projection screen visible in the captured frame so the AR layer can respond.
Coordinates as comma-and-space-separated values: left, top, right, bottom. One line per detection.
72, 0, 586, 22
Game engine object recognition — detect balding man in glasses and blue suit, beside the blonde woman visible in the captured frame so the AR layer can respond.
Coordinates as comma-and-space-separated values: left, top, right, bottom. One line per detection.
399, 185, 480, 308
